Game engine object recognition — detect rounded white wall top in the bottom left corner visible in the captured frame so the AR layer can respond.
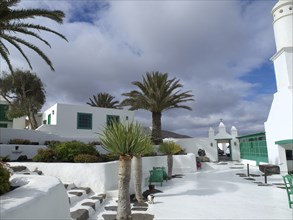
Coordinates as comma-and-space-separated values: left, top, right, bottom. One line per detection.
0, 174, 71, 220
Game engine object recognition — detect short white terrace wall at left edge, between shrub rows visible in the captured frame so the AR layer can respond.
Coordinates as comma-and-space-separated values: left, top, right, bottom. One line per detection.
0, 144, 47, 160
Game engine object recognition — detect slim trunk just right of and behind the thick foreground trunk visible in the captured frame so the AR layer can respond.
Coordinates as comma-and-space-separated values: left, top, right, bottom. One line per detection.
132, 155, 143, 202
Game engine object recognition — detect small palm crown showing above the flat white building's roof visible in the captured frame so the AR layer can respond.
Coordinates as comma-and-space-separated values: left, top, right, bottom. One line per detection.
86, 92, 119, 108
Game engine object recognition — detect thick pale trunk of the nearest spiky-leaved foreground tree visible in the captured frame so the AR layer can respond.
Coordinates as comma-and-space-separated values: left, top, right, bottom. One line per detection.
116, 156, 131, 220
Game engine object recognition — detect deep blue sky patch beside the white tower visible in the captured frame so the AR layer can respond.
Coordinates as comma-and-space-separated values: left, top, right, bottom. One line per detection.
240, 61, 277, 100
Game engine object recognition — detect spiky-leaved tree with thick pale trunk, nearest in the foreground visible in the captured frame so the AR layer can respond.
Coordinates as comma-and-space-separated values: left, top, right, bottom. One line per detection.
100, 122, 151, 220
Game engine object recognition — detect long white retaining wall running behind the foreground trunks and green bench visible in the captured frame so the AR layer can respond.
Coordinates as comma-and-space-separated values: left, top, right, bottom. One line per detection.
10, 154, 196, 193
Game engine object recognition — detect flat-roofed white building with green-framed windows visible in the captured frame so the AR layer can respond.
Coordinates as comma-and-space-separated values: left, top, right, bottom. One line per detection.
36, 103, 134, 140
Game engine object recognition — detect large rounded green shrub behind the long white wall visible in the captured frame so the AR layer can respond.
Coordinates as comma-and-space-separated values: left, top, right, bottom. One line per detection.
55, 141, 99, 162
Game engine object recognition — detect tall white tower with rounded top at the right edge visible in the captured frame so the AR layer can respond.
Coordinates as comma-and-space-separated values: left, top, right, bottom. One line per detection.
265, 0, 293, 172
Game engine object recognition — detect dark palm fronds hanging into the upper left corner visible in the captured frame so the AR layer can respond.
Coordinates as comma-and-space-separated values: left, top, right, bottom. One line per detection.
0, 0, 67, 73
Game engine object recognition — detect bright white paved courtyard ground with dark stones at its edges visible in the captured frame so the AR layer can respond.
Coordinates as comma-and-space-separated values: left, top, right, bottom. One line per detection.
95, 162, 293, 220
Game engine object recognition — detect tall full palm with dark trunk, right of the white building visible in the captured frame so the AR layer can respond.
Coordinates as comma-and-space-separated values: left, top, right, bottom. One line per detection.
121, 72, 193, 144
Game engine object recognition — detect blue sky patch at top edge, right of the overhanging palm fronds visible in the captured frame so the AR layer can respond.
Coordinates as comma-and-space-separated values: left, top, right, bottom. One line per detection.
69, 0, 110, 24
